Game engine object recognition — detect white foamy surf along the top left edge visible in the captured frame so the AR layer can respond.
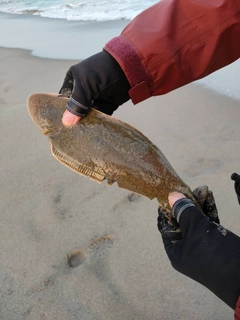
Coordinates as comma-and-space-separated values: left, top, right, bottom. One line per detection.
0, 0, 158, 21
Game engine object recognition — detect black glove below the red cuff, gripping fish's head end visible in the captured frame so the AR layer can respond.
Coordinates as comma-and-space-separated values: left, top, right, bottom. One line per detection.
59, 51, 131, 117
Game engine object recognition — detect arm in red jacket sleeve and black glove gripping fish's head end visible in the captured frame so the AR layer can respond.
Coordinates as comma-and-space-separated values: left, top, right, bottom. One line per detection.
61, 0, 240, 124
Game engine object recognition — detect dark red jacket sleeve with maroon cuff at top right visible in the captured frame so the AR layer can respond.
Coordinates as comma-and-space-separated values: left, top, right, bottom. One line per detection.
104, 0, 240, 103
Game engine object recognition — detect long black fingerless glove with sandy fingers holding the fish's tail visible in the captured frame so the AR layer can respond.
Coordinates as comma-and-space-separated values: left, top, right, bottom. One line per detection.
158, 186, 240, 309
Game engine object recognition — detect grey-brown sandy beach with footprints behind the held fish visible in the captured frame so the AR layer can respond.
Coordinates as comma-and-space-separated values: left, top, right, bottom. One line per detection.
0, 11, 240, 320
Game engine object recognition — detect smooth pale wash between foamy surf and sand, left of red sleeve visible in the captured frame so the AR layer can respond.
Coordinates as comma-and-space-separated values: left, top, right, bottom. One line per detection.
0, 13, 128, 60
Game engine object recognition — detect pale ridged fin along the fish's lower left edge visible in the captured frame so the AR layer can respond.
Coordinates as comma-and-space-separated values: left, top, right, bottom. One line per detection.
51, 144, 106, 183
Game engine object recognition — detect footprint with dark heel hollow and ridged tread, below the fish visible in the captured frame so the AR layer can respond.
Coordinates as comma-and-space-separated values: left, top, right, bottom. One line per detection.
68, 234, 115, 268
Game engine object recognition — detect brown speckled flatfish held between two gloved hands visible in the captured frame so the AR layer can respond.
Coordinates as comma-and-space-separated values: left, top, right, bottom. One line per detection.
28, 93, 198, 210
